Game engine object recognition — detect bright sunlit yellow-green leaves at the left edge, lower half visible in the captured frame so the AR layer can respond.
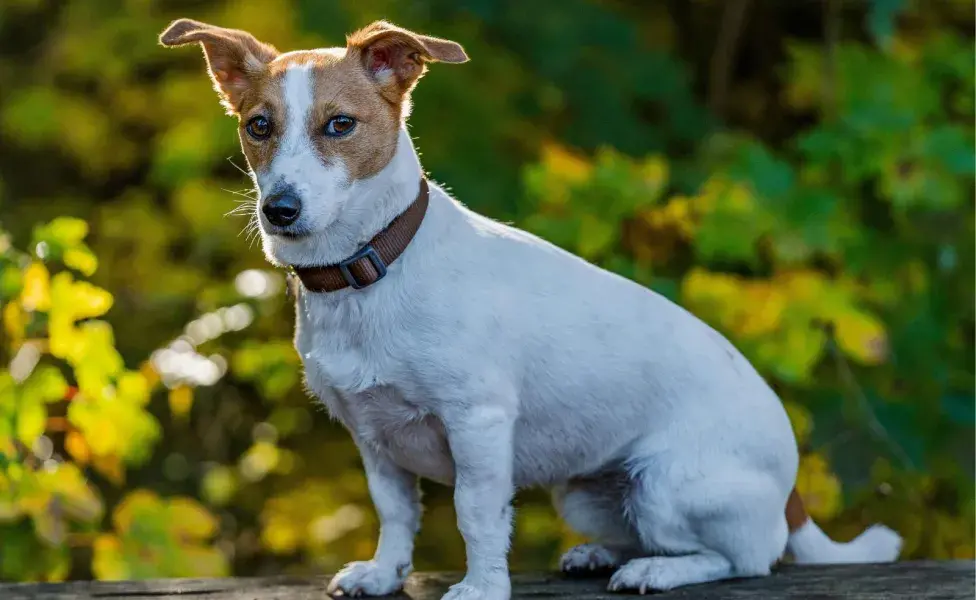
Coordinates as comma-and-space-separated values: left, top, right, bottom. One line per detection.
0, 223, 227, 580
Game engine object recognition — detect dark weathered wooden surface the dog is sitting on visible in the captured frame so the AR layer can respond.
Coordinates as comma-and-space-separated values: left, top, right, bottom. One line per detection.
0, 561, 976, 600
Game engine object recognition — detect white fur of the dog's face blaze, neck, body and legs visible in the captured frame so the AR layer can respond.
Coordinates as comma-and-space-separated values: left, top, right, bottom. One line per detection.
252, 70, 892, 600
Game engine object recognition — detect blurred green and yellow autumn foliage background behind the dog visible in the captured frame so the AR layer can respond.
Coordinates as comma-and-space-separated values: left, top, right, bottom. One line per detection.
0, 0, 976, 580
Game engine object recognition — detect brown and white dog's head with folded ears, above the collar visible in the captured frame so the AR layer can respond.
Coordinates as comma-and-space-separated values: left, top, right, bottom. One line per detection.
160, 19, 468, 264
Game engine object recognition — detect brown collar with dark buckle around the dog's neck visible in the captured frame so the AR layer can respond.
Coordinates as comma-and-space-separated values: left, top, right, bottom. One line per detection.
293, 178, 430, 292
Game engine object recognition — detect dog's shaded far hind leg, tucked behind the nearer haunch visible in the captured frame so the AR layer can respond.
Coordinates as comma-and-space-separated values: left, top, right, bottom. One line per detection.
553, 472, 639, 573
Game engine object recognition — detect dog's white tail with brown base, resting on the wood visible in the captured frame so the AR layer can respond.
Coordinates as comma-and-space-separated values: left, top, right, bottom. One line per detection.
786, 489, 901, 565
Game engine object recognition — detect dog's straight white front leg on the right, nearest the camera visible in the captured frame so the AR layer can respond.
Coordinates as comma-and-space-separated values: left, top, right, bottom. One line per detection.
443, 406, 514, 600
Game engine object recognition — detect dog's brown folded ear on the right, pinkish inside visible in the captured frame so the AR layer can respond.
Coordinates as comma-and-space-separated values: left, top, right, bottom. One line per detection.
346, 21, 468, 100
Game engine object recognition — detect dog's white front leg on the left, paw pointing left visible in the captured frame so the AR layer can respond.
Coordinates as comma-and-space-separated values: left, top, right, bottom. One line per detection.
328, 444, 421, 596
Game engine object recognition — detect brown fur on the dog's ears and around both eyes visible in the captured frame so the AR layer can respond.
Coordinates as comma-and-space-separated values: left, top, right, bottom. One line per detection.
160, 19, 468, 180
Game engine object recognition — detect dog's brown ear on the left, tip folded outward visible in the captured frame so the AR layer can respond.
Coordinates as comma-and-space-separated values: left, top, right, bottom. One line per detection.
159, 19, 278, 114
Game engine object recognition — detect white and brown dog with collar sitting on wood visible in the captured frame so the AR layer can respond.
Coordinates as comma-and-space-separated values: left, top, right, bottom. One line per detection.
160, 19, 901, 600
